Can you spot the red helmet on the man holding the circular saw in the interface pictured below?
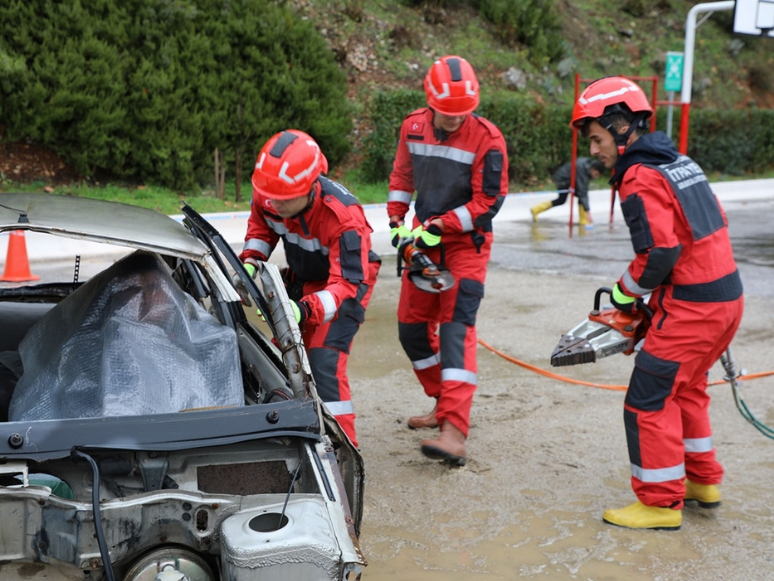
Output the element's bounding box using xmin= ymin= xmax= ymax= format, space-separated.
xmin=425 ymin=55 xmax=479 ymax=117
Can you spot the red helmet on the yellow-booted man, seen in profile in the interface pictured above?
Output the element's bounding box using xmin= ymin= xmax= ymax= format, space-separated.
xmin=570 ymin=77 xmax=653 ymax=129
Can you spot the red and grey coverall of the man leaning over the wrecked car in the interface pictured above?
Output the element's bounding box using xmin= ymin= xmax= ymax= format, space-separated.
xmin=239 ymin=177 xmax=381 ymax=446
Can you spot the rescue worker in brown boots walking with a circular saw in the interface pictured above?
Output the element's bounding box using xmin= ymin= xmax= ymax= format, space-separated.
xmin=387 ymin=56 xmax=508 ymax=466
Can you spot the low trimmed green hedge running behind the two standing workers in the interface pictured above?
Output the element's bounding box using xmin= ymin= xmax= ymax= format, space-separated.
xmin=361 ymin=90 xmax=774 ymax=184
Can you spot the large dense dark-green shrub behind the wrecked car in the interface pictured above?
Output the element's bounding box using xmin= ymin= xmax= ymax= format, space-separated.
xmin=0 ymin=0 xmax=352 ymax=189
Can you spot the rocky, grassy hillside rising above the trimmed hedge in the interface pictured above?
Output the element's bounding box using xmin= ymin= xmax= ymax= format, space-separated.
xmin=290 ymin=0 xmax=774 ymax=109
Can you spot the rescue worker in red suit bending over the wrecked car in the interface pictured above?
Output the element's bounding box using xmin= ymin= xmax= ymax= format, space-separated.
xmin=239 ymin=129 xmax=380 ymax=446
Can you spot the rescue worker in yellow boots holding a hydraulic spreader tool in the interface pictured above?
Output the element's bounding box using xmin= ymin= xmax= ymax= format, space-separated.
xmin=572 ymin=77 xmax=744 ymax=530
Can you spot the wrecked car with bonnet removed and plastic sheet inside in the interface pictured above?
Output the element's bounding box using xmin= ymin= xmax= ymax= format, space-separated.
xmin=0 ymin=194 xmax=365 ymax=581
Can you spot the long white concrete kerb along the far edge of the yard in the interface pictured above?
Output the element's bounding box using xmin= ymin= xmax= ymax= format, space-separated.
xmin=0 ymin=179 xmax=774 ymax=271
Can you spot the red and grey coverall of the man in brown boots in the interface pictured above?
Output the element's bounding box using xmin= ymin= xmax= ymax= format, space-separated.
xmin=387 ymin=108 xmax=508 ymax=436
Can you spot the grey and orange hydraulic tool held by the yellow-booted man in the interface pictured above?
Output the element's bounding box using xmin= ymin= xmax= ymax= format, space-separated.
xmin=551 ymin=287 xmax=653 ymax=367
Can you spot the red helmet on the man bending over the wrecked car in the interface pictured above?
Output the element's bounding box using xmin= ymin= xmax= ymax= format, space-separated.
xmin=253 ymin=129 xmax=328 ymax=200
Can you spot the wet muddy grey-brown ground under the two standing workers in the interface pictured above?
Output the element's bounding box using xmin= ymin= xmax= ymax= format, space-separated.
xmin=350 ymin=207 xmax=774 ymax=581
